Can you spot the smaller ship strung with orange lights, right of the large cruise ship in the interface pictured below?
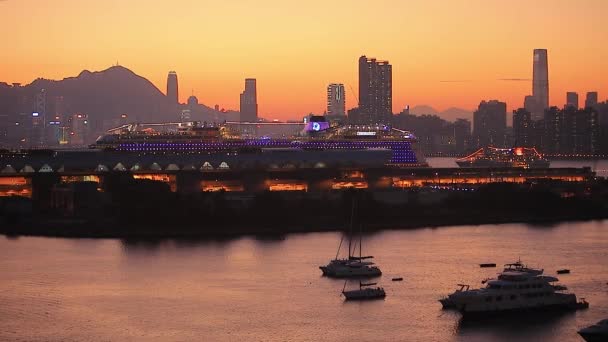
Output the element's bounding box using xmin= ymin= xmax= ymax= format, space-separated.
xmin=456 ymin=147 xmax=549 ymax=169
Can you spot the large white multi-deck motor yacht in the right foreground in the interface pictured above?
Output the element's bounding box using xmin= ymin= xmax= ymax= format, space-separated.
xmin=442 ymin=271 xmax=589 ymax=316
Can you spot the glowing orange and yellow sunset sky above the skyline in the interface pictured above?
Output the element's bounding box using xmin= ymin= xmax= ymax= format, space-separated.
xmin=0 ymin=0 xmax=608 ymax=119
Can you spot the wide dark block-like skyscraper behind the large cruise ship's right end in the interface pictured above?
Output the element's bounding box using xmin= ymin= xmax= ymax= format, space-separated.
xmin=359 ymin=56 xmax=393 ymax=124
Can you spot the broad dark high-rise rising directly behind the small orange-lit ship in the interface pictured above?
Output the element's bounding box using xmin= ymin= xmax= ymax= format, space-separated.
xmin=473 ymin=100 xmax=507 ymax=147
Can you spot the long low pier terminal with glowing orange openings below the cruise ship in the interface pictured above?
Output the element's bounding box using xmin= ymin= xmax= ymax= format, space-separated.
xmin=0 ymin=167 xmax=595 ymax=197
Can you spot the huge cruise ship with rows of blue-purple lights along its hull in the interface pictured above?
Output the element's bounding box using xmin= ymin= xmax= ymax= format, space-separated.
xmin=91 ymin=121 xmax=428 ymax=167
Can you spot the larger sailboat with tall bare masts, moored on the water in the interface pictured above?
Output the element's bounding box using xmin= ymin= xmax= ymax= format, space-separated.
xmin=319 ymin=199 xmax=382 ymax=278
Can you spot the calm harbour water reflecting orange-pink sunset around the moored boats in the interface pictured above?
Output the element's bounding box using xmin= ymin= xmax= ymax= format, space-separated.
xmin=0 ymin=221 xmax=608 ymax=341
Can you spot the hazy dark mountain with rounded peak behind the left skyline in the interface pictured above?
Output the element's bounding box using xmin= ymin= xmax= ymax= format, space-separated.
xmin=0 ymin=66 xmax=238 ymax=132
